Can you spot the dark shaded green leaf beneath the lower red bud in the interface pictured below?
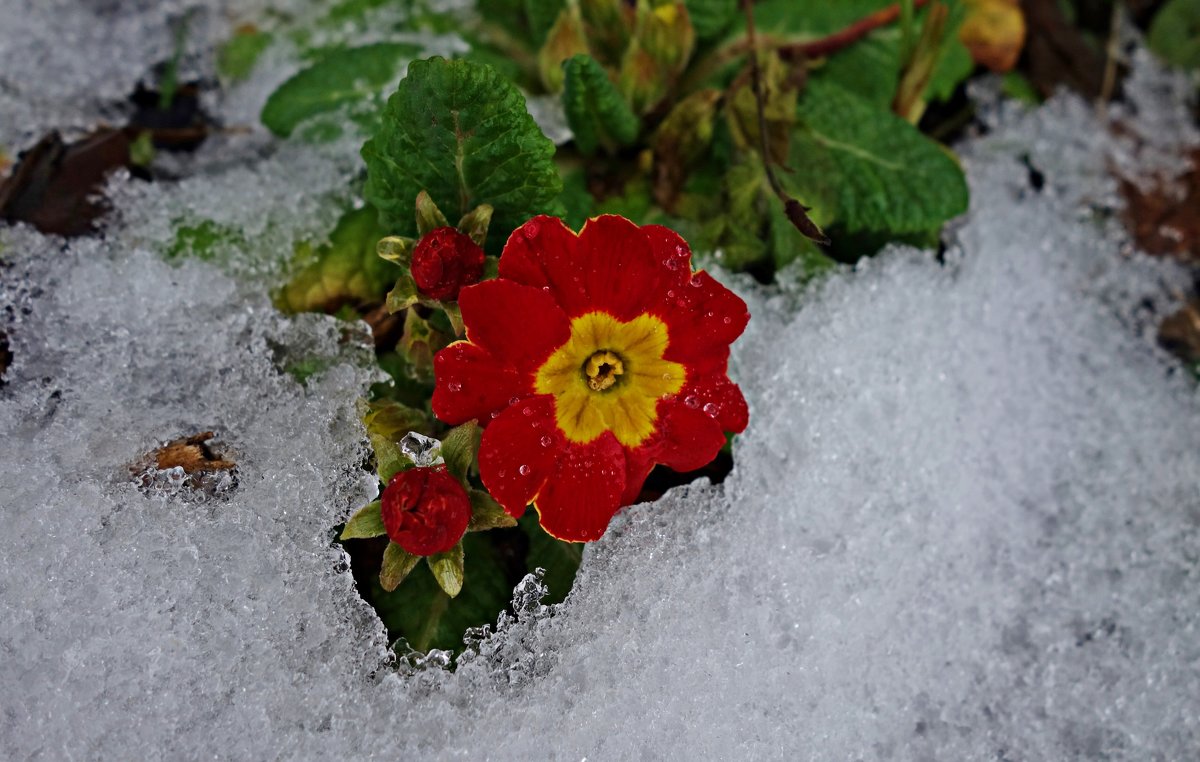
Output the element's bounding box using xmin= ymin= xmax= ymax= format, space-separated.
xmin=367 ymin=534 xmax=516 ymax=650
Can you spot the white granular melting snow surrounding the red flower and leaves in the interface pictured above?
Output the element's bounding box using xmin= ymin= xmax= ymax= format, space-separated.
xmin=0 ymin=4 xmax=1200 ymax=760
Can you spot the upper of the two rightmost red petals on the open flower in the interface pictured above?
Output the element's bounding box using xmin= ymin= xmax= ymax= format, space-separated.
xmin=653 ymin=271 xmax=750 ymax=371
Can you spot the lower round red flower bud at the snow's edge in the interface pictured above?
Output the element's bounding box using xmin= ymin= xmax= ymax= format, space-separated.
xmin=379 ymin=466 xmax=470 ymax=556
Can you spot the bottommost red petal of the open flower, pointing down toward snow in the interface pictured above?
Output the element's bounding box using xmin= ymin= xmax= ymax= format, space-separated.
xmin=535 ymin=432 xmax=625 ymax=542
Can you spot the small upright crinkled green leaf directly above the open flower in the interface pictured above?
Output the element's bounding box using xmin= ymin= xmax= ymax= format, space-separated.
xmin=563 ymin=54 xmax=641 ymax=156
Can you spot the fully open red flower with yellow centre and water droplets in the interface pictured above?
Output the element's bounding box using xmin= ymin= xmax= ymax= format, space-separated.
xmin=433 ymin=215 xmax=750 ymax=541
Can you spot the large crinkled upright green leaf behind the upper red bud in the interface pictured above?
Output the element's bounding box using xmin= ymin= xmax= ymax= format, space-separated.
xmin=362 ymin=58 xmax=562 ymax=248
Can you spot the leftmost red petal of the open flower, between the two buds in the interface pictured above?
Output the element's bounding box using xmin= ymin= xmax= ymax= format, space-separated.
xmin=433 ymin=341 xmax=530 ymax=425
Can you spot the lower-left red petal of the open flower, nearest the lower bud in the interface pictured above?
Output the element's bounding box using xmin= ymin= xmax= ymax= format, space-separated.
xmin=479 ymin=395 xmax=564 ymax=517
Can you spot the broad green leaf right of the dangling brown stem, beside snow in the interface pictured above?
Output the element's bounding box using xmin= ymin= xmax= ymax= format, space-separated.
xmin=785 ymin=82 xmax=967 ymax=233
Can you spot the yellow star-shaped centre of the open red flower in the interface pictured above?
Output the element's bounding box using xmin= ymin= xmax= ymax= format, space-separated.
xmin=534 ymin=312 xmax=686 ymax=448
